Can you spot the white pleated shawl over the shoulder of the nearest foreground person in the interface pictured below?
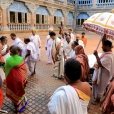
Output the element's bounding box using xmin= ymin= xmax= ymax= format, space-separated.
xmin=48 ymin=85 xmax=84 ymax=114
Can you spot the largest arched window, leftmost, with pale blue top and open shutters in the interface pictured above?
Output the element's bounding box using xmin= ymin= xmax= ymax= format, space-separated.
xmin=7 ymin=1 xmax=30 ymax=23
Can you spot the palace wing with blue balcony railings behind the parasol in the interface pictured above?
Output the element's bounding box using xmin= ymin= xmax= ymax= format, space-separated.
xmin=76 ymin=0 xmax=114 ymax=28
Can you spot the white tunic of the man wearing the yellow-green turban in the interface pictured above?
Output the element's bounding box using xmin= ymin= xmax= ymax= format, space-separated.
xmin=30 ymin=35 xmax=41 ymax=55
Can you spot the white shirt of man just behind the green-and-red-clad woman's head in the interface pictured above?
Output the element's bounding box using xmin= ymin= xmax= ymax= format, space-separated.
xmin=13 ymin=37 xmax=25 ymax=57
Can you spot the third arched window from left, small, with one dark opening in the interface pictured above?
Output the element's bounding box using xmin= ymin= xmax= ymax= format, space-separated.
xmin=54 ymin=9 xmax=64 ymax=24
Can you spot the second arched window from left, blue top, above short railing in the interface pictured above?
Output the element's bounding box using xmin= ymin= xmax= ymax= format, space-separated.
xmin=35 ymin=6 xmax=49 ymax=24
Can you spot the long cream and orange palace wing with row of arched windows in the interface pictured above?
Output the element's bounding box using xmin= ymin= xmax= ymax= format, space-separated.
xmin=0 ymin=0 xmax=75 ymax=33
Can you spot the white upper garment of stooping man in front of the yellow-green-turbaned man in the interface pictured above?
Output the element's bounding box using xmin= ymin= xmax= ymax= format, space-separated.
xmin=26 ymin=42 xmax=38 ymax=61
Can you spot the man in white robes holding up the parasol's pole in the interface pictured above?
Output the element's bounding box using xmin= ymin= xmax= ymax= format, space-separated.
xmin=92 ymin=40 xmax=114 ymax=104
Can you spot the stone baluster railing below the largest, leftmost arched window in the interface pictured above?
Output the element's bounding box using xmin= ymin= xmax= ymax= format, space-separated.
xmin=8 ymin=23 xmax=30 ymax=31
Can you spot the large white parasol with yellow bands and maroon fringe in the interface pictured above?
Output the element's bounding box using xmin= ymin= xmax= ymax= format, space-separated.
xmin=83 ymin=10 xmax=114 ymax=50
